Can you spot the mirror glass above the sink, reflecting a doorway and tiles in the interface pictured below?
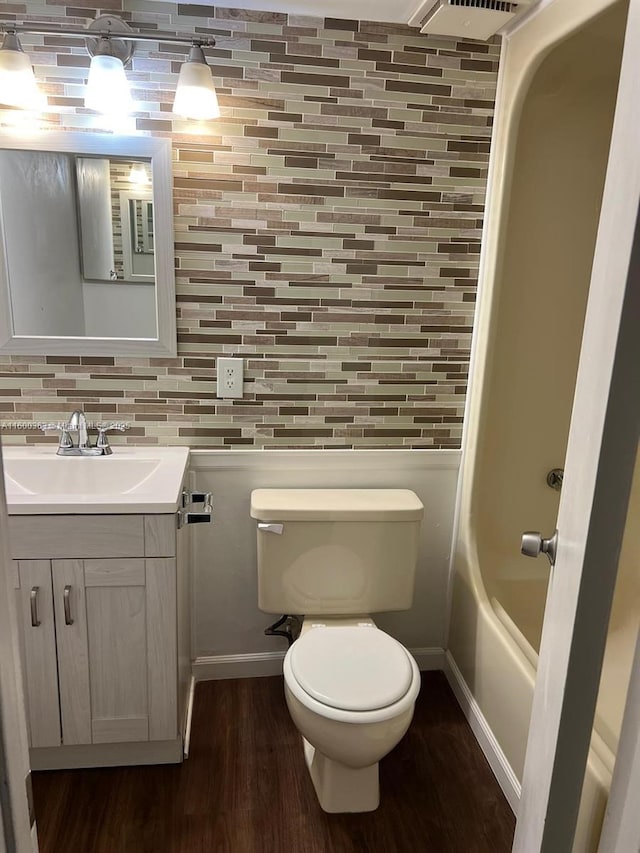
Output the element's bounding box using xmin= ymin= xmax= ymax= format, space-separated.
xmin=0 ymin=149 xmax=158 ymax=339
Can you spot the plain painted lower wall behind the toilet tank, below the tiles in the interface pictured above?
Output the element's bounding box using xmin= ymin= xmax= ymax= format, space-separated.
xmin=186 ymin=450 xmax=460 ymax=675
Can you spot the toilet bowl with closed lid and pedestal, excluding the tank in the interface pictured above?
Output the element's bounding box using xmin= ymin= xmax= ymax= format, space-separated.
xmin=284 ymin=617 xmax=420 ymax=812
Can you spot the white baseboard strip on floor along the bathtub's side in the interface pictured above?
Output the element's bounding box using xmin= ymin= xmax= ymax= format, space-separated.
xmin=444 ymin=652 xmax=521 ymax=816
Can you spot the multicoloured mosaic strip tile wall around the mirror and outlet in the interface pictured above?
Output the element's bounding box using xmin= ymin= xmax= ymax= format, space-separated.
xmin=0 ymin=0 xmax=499 ymax=448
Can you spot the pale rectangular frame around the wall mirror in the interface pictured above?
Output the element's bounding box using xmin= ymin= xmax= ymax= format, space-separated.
xmin=0 ymin=131 xmax=177 ymax=357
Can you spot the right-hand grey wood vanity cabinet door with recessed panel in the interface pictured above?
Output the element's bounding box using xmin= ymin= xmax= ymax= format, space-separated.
xmin=45 ymin=558 xmax=178 ymax=746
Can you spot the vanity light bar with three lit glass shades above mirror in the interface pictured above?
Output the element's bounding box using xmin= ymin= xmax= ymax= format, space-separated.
xmin=0 ymin=15 xmax=220 ymax=119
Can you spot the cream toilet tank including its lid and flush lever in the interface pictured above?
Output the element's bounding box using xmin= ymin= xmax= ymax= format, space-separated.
xmin=251 ymin=489 xmax=424 ymax=616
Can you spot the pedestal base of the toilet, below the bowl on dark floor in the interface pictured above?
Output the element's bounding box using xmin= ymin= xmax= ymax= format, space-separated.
xmin=302 ymin=738 xmax=380 ymax=814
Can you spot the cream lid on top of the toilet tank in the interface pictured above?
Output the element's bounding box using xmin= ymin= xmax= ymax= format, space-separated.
xmin=251 ymin=489 xmax=424 ymax=521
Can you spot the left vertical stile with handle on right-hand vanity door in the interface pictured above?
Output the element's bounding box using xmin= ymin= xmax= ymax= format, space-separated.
xmin=52 ymin=560 xmax=91 ymax=745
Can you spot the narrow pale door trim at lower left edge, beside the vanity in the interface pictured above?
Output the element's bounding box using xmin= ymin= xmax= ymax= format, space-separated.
xmin=0 ymin=446 xmax=38 ymax=853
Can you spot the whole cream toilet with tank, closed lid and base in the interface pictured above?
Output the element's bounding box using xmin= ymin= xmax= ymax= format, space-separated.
xmin=251 ymin=489 xmax=424 ymax=812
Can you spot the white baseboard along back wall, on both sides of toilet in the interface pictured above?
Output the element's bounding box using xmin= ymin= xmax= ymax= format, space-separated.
xmin=191 ymin=648 xmax=445 ymax=681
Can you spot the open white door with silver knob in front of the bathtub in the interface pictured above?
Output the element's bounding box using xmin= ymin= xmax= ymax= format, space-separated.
xmin=513 ymin=0 xmax=640 ymax=853
